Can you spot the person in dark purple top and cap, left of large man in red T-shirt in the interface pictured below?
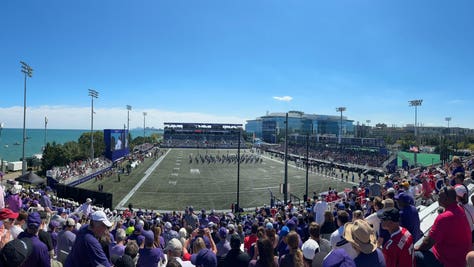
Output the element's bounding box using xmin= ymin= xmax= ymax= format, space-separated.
xmin=395 ymin=192 xmax=423 ymax=243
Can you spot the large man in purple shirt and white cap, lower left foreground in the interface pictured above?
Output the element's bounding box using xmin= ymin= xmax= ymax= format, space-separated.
xmin=64 ymin=211 xmax=112 ymax=267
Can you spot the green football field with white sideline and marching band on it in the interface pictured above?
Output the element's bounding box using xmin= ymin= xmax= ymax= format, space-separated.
xmin=79 ymin=149 xmax=352 ymax=211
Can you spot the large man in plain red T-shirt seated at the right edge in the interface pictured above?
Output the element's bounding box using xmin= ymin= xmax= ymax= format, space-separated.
xmin=415 ymin=186 xmax=471 ymax=267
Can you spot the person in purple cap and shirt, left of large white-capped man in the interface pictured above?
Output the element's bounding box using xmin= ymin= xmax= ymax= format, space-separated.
xmin=18 ymin=212 xmax=51 ymax=267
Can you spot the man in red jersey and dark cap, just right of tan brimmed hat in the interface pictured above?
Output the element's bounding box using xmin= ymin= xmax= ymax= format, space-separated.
xmin=380 ymin=208 xmax=415 ymax=267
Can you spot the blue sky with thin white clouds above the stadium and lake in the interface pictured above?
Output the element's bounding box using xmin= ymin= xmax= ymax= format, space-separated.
xmin=0 ymin=0 xmax=474 ymax=129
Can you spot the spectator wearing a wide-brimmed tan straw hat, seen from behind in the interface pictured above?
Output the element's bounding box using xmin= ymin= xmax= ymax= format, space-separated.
xmin=344 ymin=220 xmax=385 ymax=267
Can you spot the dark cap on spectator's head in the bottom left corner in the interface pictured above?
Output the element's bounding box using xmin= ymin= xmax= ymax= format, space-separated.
xmin=0 ymin=238 xmax=33 ymax=267
